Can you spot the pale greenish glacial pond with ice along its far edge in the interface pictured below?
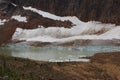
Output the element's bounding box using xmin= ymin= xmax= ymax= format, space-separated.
xmin=0 ymin=44 xmax=120 ymax=62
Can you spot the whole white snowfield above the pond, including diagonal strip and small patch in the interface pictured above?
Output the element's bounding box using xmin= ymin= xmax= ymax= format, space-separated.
xmin=12 ymin=7 xmax=120 ymax=42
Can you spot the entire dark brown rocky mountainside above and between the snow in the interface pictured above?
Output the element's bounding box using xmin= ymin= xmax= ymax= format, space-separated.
xmin=0 ymin=0 xmax=120 ymax=43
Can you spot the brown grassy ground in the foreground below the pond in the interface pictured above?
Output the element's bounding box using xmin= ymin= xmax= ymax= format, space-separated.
xmin=0 ymin=52 xmax=120 ymax=80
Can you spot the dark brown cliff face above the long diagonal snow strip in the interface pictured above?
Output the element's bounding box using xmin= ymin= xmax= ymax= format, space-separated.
xmin=6 ymin=0 xmax=120 ymax=24
